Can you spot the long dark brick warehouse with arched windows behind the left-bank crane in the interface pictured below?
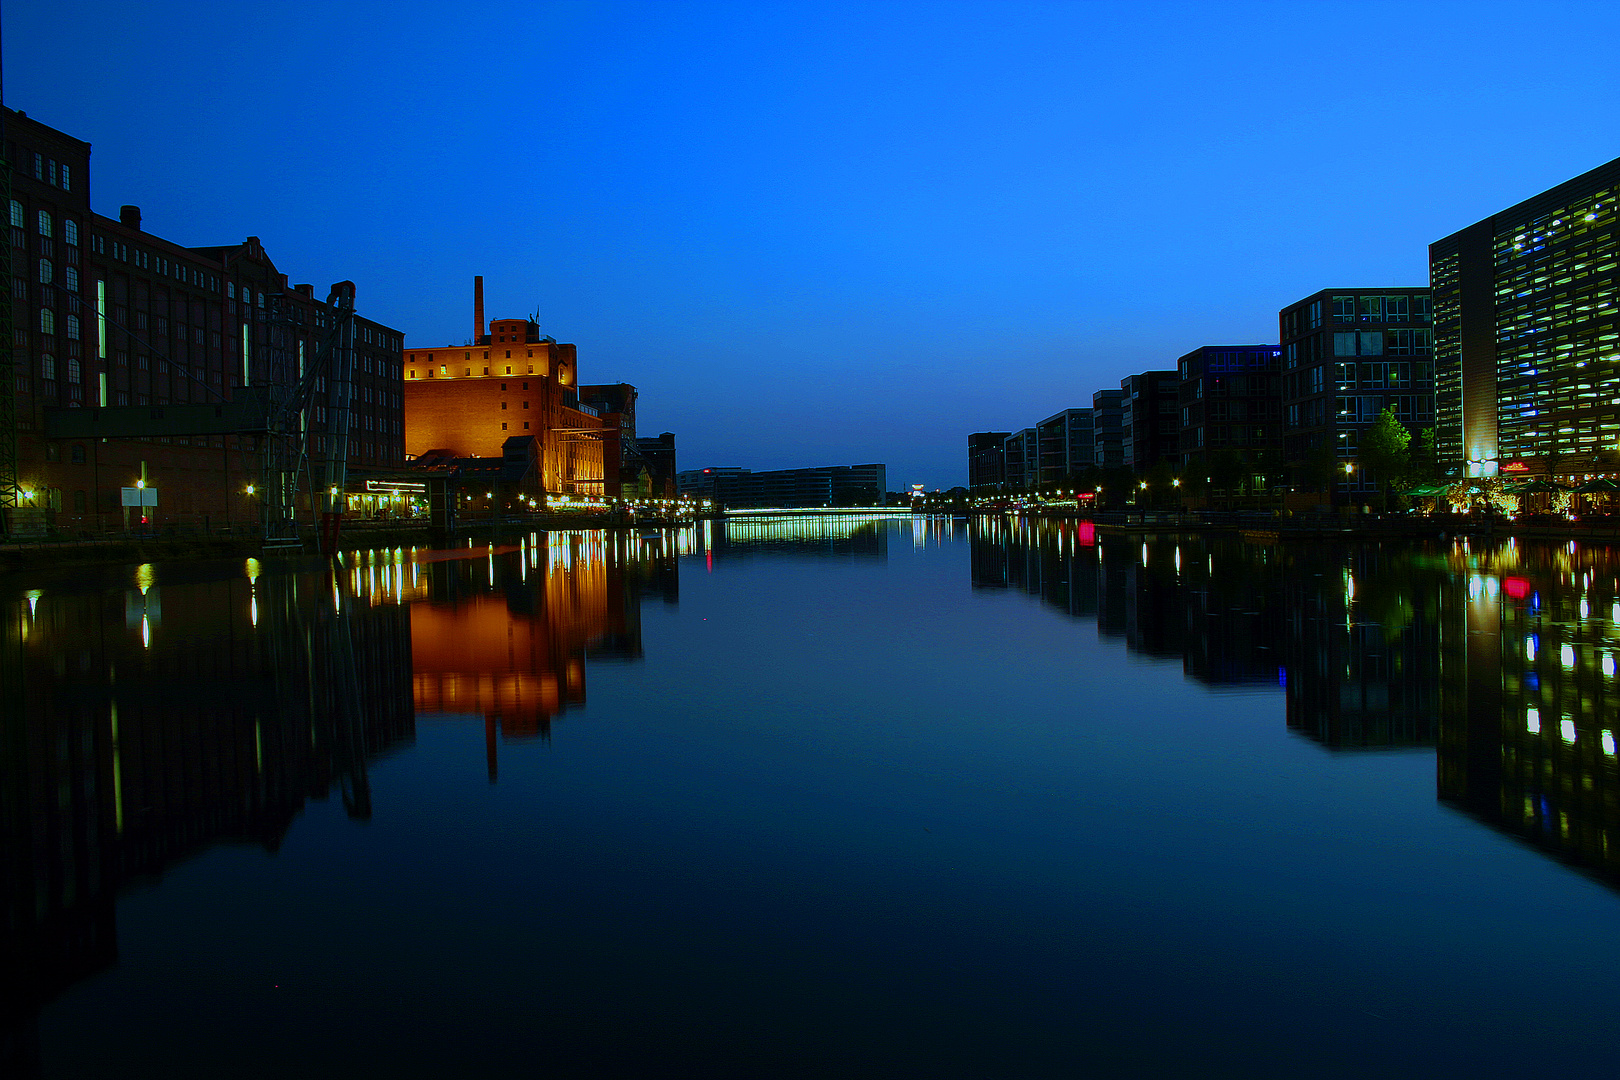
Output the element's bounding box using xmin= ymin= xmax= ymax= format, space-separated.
xmin=0 ymin=110 xmax=403 ymax=531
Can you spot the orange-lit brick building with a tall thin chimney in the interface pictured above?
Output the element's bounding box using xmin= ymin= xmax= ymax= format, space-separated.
xmin=405 ymin=277 xmax=617 ymax=495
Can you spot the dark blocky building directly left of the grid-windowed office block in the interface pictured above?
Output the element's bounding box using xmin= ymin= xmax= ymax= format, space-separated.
xmin=1176 ymin=345 xmax=1283 ymax=466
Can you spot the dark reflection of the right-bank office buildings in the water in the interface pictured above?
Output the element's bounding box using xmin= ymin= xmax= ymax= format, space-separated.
xmin=972 ymin=520 xmax=1620 ymax=887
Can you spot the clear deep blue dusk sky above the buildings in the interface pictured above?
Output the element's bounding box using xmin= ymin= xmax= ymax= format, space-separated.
xmin=3 ymin=0 xmax=1620 ymax=489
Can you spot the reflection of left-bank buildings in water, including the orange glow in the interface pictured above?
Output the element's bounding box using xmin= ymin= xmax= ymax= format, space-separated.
xmin=0 ymin=529 xmax=677 ymax=1075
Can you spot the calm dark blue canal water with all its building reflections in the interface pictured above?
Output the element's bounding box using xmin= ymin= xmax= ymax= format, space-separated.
xmin=0 ymin=520 xmax=1620 ymax=1078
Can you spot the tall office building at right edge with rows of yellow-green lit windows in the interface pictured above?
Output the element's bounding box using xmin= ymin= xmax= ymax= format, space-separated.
xmin=1429 ymin=159 xmax=1620 ymax=476
